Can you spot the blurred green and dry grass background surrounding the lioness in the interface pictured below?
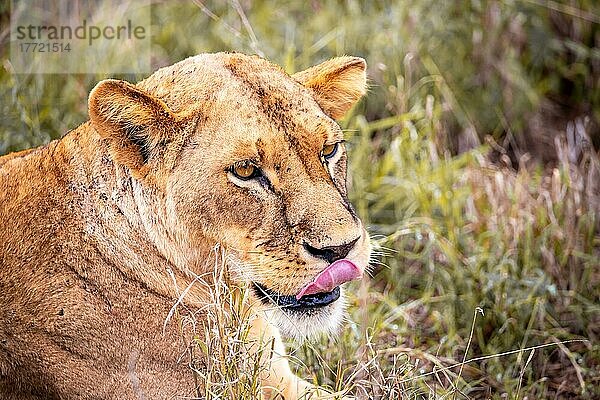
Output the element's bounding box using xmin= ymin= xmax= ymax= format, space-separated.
xmin=0 ymin=0 xmax=600 ymax=399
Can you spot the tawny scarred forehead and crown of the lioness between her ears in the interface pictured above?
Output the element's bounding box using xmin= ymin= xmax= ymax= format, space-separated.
xmin=139 ymin=53 xmax=343 ymax=170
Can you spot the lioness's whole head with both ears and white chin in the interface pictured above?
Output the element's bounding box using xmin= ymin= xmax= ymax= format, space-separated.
xmin=89 ymin=53 xmax=370 ymax=337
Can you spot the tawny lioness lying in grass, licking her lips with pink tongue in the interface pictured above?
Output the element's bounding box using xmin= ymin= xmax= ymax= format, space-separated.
xmin=0 ymin=53 xmax=370 ymax=400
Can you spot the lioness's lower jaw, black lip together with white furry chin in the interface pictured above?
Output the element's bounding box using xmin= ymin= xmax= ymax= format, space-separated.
xmin=252 ymin=283 xmax=346 ymax=341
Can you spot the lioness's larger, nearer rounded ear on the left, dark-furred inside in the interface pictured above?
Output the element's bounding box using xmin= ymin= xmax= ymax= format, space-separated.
xmin=88 ymin=79 xmax=176 ymax=172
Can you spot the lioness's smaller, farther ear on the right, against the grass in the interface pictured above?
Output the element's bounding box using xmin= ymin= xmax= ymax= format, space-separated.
xmin=292 ymin=56 xmax=367 ymax=119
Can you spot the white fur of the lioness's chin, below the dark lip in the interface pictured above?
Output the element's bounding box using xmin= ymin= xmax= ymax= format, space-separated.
xmin=264 ymin=288 xmax=346 ymax=342
